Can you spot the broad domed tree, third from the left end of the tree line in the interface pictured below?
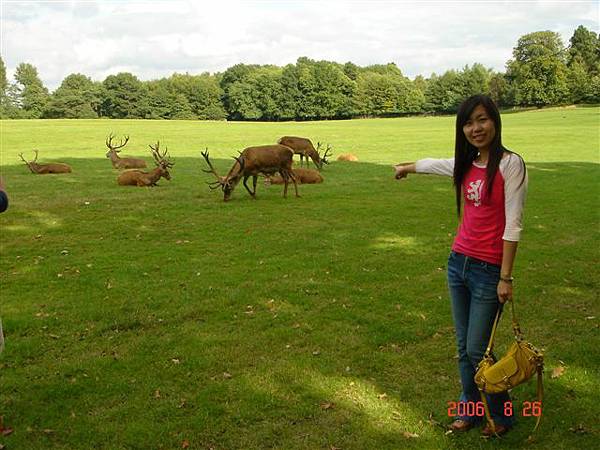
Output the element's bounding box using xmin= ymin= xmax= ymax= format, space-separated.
xmin=46 ymin=73 xmax=101 ymax=119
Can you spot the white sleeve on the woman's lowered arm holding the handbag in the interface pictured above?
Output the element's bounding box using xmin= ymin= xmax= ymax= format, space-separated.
xmin=500 ymin=153 xmax=528 ymax=242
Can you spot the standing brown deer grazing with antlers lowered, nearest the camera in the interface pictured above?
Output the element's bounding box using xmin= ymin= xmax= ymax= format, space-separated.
xmin=202 ymin=144 xmax=300 ymax=201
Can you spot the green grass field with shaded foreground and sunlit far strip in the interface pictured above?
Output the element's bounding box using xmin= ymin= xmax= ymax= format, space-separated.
xmin=0 ymin=108 xmax=600 ymax=450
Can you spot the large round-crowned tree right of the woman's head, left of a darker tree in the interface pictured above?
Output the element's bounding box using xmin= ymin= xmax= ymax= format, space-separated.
xmin=507 ymin=31 xmax=569 ymax=106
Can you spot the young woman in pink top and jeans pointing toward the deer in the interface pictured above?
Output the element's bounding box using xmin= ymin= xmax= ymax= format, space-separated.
xmin=394 ymin=95 xmax=527 ymax=436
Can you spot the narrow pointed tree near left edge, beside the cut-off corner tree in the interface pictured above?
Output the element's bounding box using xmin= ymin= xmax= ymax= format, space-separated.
xmin=14 ymin=63 xmax=49 ymax=119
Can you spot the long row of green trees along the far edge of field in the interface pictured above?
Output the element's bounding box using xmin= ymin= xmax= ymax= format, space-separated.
xmin=0 ymin=26 xmax=600 ymax=121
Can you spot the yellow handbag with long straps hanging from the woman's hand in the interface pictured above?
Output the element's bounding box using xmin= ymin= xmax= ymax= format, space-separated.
xmin=475 ymin=301 xmax=544 ymax=432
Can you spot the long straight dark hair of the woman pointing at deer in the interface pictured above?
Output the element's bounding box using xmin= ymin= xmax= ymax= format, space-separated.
xmin=454 ymin=94 xmax=525 ymax=216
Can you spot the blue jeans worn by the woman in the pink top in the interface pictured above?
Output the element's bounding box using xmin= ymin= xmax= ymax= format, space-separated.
xmin=448 ymin=252 xmax=514 ymax=427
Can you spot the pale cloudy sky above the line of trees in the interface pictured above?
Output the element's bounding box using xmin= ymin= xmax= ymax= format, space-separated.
xmin=0 ymin=0 xmax=600 ymax=90
